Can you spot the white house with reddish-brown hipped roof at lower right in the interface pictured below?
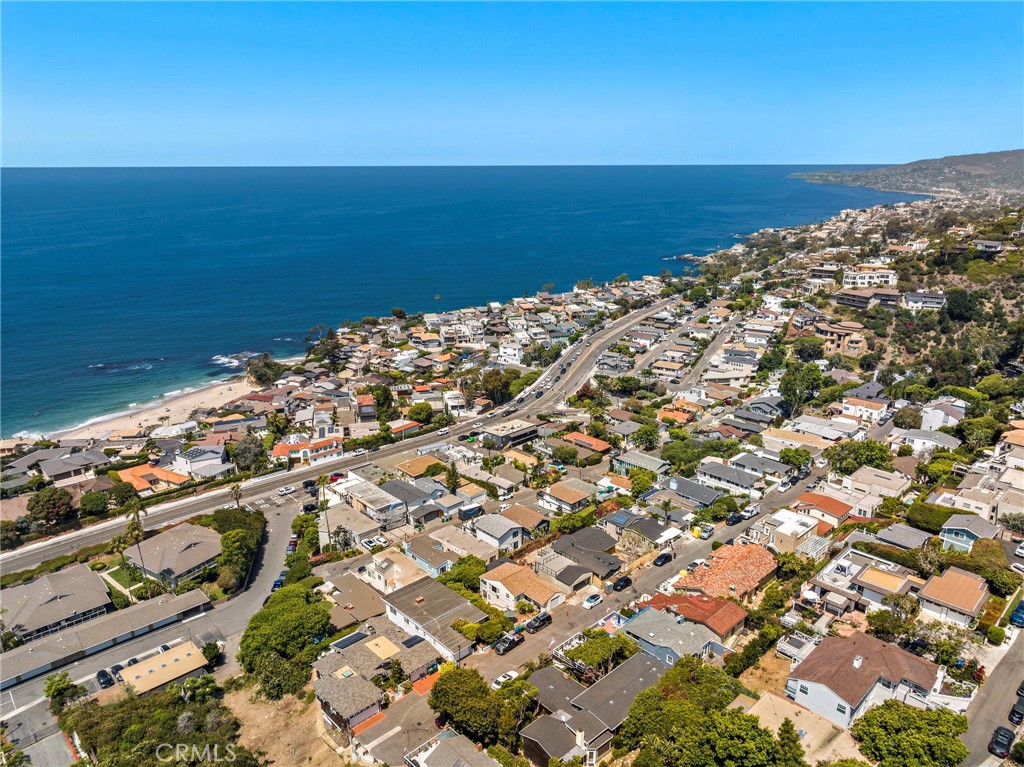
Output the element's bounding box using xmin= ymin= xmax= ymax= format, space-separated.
xmin=785 ymin=632 xmax=943 ymax=727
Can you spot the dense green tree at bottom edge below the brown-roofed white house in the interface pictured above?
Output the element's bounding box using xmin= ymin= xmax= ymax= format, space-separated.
xmin=851 ymin=700 xmax=969 ymax=767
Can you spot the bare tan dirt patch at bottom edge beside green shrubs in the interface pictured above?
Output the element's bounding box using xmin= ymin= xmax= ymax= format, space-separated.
xmin=224 ymin=689 xmax=346 ymax=767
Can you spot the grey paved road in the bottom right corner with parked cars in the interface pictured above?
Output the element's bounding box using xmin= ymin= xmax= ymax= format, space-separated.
xmin=961 ymin=629 xmax=1024 ymax=767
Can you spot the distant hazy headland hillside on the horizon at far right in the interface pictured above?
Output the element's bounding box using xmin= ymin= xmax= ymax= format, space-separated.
xmin=795 ymin=150 xmax=1024 ymax=195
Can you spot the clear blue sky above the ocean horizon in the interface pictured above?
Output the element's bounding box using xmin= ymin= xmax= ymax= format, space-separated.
xmin=0 ymin=2 xmax=1024 ymax=167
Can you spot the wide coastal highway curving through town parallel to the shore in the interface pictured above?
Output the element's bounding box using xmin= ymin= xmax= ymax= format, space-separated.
xmin=0 ymin=299 xmax=675 ymax=572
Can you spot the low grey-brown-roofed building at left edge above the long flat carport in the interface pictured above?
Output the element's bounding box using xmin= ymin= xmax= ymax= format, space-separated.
xmin=3 ymin=564 xmax=113 ymax=643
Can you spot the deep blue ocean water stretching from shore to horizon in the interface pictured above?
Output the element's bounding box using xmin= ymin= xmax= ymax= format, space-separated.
xmin=0 ymin=166 xmax=914 ymax=436
